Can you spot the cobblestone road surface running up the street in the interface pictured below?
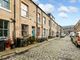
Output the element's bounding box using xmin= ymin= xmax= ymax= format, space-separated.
xmin=6 ymin=37 xmax=80 ymax=60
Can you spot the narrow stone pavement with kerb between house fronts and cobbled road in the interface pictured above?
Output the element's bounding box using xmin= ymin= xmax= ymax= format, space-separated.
xmin=0 ymin=38 xmax=56 ymax=60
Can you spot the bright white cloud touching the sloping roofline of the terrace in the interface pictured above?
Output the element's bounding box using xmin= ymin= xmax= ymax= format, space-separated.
xmin=39 ymin=4 xmax=54 ymax=13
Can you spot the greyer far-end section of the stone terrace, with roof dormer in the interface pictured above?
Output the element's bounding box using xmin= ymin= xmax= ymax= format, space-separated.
xmin=48 ymin=14 xmax=62 ymax=37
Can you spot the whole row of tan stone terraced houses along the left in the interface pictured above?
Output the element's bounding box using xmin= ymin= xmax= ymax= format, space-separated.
xmin=0 ymin=0 xmax=62 ymax=50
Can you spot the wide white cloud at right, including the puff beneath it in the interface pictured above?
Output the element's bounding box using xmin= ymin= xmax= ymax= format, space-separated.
xmin=58 ymin=5 xmax=79 ymax=18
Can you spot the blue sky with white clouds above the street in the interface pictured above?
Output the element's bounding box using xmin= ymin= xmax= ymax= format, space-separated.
xmin=33 ymin=0 xmax=80 ymax=26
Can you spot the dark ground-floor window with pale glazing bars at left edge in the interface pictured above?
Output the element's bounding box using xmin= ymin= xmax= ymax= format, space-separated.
xmin=0 ymin=20 xmax=9 ymax=37
